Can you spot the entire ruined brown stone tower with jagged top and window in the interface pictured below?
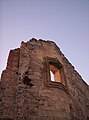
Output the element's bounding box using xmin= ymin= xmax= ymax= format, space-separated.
xmin=0 ymin=38 xmax=89 ymax=120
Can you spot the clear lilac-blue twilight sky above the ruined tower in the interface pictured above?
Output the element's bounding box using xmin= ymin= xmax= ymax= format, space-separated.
xmin=0 ymin=0 xmax=89 ymax=84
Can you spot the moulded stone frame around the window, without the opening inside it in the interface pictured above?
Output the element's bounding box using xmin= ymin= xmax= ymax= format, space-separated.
xmin=44 ymin=57 xmax=68 ymax=93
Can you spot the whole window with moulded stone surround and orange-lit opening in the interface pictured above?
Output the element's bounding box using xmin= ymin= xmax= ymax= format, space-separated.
xmin=45 ymin=57 xmax=67 ymax=91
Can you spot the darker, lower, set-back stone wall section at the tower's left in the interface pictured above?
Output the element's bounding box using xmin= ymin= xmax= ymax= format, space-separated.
xmin=0 ymin=49 xmax=19 ymax=119
